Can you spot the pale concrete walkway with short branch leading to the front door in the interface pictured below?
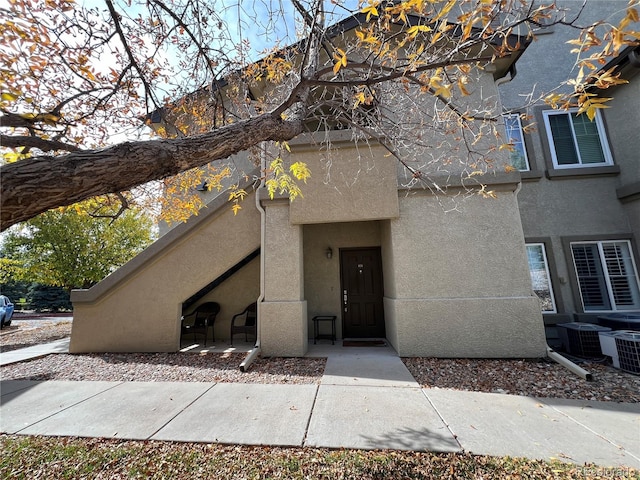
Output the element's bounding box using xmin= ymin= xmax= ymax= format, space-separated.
xmin=0 ymin=346 xmax=640 ymax=468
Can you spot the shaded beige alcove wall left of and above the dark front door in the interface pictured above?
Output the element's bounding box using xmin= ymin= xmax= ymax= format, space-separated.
xmin=303 ymin=222 xmax=381 ymax=338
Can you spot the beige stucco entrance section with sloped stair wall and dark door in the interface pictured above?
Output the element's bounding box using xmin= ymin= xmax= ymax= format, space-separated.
xmin=71 ymin=126 xmax=545 ymax=357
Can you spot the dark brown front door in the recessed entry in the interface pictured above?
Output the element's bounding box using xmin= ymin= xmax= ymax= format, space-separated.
xmin=340 ymin=247 xmax=385 ymax=338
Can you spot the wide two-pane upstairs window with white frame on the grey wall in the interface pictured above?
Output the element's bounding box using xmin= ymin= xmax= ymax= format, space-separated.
xmin=543 ymin=110 xmax=613 ymax=169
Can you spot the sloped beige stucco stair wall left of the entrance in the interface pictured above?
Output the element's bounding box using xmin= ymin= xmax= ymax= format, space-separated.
xmin=69 ymin=191 xmax=260 ymax=353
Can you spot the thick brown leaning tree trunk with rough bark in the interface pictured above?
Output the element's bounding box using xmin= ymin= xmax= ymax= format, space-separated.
xmin=0 ymin=114 xmax=303 ymax=230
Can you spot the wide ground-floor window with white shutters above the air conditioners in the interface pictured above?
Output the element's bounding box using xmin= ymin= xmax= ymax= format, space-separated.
xmin=571 ymin=240 xmax=640 ymax=312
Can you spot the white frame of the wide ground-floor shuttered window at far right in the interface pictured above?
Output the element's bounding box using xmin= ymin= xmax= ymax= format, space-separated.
xmin=563 ymin=235 xmax=640 ymax=314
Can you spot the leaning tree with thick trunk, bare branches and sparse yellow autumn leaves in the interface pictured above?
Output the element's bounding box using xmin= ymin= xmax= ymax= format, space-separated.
xmin=0 ymin=0 xmax=640 ymax=228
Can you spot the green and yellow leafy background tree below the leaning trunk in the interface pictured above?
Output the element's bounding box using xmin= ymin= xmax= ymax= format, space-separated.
xmin=0 ymin=201 xmax=153 ymax=290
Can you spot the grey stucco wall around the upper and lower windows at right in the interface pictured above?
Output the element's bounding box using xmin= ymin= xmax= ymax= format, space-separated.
xmin=508 ymin=79 xmax=640 ymax=314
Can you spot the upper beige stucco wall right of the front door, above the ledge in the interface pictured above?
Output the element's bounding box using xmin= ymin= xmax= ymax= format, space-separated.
xmin=390 ymin=192 xmax=531 ymax=298
